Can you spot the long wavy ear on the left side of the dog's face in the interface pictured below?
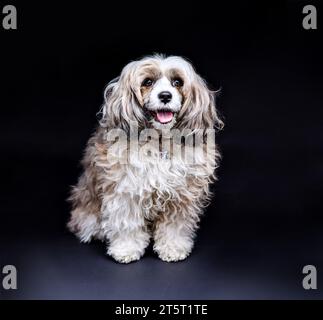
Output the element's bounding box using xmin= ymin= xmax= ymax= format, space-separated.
xmin=98 ymin=62 xmax=144 ymax=132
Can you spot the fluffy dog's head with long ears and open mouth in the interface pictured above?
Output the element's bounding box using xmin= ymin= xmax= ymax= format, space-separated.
xmin=100 ymin=55 xmax=223 ymax=130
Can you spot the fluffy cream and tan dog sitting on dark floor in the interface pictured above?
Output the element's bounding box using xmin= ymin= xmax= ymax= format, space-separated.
xmin=68 ymin=54 xmax=223 ymax=263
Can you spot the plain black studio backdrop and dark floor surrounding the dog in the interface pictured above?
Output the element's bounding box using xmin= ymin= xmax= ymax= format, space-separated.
xmin=0 ymin=1 xmax=323 ymax=299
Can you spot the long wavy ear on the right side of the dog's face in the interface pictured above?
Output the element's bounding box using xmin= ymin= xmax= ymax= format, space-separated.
xmin=179 ymin=74 xmax=224 ymax=130
